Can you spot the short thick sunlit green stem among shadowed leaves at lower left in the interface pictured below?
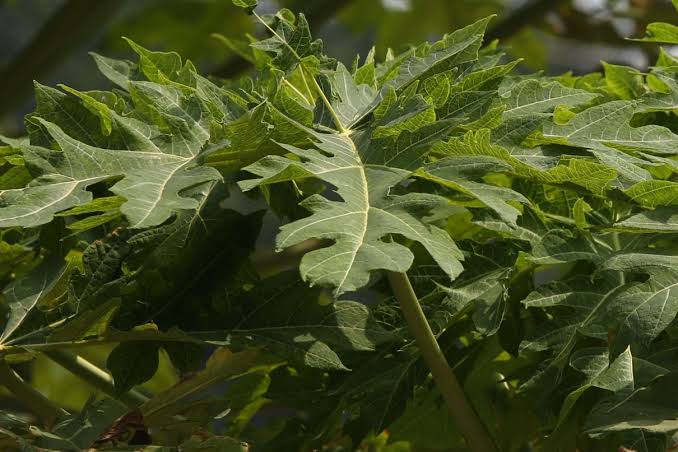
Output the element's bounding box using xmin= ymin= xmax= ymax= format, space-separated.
xmin=43 ymin=350 xmax=148 ymax=408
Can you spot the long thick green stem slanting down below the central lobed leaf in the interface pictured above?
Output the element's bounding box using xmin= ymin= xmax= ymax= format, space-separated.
xmin=388 ymin=272 xmax=497 ymax=452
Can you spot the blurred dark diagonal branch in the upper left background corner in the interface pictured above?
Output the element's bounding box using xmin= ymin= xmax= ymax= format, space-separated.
xmin=0 ymin=0 xmax=125 ymax=120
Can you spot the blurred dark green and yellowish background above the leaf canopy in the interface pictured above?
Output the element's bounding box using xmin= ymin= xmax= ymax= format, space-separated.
xmin=0 ymin=0 xmax=676 ymax=136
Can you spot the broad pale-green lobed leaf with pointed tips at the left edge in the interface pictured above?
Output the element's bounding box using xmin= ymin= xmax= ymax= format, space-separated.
xmin=0 ymin=108 xmax=220 ymax=228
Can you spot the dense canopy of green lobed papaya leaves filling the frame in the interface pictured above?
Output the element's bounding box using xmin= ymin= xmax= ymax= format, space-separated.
xmin=0 ymin=0 xmax=678 ymax=451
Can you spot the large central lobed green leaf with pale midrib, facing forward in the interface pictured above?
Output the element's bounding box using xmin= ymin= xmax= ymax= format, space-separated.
xmin=240 ymin=109 xmax=461 ymax=296
